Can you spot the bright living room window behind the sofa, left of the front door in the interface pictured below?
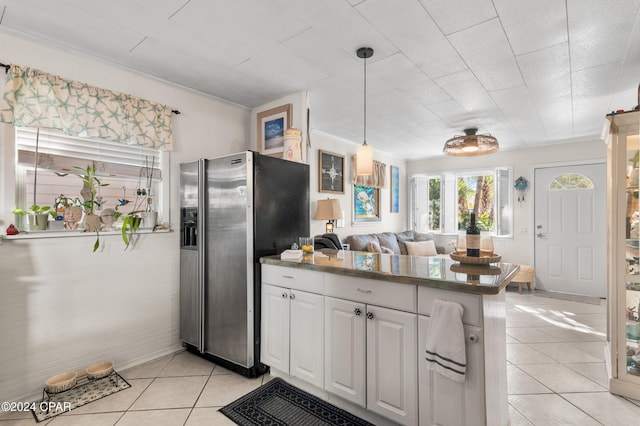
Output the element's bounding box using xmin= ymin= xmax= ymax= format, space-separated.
xmin=410 ymin=168 xmax=512 ymax=237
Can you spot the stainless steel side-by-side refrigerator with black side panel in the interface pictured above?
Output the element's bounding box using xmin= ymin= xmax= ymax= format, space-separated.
xmin=180 ymin=151 xmax=309 ymax=377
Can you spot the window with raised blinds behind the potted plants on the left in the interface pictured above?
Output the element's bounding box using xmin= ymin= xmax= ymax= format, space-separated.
xmin=16 ymin=128 xmax=162 ymax=220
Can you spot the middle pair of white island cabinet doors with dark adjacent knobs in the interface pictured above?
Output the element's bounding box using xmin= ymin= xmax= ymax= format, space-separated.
xmin=325 ymin=297 xmax=418 ymax=425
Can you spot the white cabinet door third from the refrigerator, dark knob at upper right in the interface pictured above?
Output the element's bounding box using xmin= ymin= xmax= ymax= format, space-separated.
xmin=324 ymin=297 xmax=366 ymax=407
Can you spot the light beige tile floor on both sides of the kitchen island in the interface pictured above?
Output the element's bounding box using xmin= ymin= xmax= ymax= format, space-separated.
xmin=0 ymin=291 xmax=640 ymax=426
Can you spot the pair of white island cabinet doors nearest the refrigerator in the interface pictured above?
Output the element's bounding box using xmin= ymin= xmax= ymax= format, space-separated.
xmin=260 ymin=284 xmax=324 ymax=388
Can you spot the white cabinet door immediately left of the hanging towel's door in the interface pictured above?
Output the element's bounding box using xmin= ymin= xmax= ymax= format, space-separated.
xmin=367 ymin=305 xmax=418 ymax=425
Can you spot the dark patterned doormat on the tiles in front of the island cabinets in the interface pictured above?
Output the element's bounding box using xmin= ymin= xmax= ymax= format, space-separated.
xmin=220 ymin=378 xmax=373 ymax=426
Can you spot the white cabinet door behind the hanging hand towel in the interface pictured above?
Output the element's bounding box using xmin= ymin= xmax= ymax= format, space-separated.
xmin=418 ymin=315 xmax=486 ymax=426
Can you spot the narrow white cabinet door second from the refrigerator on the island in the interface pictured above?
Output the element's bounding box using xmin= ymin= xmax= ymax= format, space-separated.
xmin=289 ymin=290 xmax=324 ymax=389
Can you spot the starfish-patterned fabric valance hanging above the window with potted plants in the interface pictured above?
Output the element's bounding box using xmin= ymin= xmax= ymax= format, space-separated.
xmin=0 ymin=65 xmax=173 ymax=151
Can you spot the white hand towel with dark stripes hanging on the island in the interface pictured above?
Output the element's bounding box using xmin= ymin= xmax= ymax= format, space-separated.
xmin=426 ymin=300 xmax=467 ymax=382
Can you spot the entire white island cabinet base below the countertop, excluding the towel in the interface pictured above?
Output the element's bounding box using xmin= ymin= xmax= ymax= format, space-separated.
xmin=260 ymin=265 xmax=509 ymax=426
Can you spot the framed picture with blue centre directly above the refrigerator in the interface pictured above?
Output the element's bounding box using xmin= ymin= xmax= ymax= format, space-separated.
xmin=256 ymin=104 xmax=293 ymax=157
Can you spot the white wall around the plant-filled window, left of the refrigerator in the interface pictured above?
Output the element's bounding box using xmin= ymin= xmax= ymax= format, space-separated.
xmin=0 ymin=33 xmax=253 ymax=401
